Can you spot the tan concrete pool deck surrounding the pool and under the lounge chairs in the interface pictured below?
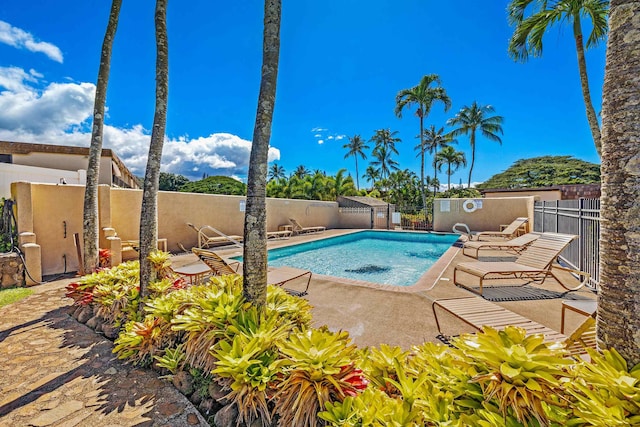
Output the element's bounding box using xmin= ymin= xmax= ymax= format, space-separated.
xmin=181 ymin=230 xmax=595 ymax=349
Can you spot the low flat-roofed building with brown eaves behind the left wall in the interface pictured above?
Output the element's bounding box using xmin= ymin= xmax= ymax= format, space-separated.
xmin=0 ymin=141 xmax=140 ymax=197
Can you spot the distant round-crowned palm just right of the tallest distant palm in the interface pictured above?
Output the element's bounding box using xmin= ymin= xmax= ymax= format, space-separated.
xmin=447 ymin=101 xmax=504 ymax=188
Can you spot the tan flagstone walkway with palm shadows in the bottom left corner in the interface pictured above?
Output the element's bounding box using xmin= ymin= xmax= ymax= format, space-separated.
xmin=0 ymin=279 xmax=208 ymax=427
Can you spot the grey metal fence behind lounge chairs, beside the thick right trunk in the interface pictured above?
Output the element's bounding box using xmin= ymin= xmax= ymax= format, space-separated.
xmin=533 ymin=199 xmax=600 ymax=290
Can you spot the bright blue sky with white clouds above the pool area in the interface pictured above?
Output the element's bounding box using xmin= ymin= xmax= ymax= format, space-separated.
xmin=0 ymin=0 xmax=605 ymax=183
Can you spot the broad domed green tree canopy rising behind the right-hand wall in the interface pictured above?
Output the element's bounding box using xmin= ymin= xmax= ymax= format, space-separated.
xmin=478 ymin=156 xmax=600 ymax=189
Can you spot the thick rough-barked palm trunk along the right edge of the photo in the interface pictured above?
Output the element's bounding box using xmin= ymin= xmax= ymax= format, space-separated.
xmin=598 ymin=0 xmax=640 ymax=367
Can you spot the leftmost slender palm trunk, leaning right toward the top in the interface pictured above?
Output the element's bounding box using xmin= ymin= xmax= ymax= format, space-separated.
xmin=82 ymin=0 xmax=122 ymax=274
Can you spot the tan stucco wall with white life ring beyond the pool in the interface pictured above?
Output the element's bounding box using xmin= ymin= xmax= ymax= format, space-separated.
xmin=433 ymin=197 xmax=534 ymax=232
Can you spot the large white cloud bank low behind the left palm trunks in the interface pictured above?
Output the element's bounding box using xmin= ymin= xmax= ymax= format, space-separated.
xmin=0 ymin=67 xmax=280 ymax=179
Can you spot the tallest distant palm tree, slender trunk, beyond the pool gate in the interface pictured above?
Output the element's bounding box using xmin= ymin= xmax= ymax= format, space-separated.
xmin=395 ymin=74 xmax=451 ymax=213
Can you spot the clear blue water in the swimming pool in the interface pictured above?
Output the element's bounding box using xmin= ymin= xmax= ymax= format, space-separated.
xmin=262 ymin=231 xmax=459 ymax=286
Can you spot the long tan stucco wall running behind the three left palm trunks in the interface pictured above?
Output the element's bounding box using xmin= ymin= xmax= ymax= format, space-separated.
xmin=11 ymin=182 xmax=343 ymax=280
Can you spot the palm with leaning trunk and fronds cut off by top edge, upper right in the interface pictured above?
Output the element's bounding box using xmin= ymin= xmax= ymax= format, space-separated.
xmin=507 ymin=0 xmax=609 ymax=155
